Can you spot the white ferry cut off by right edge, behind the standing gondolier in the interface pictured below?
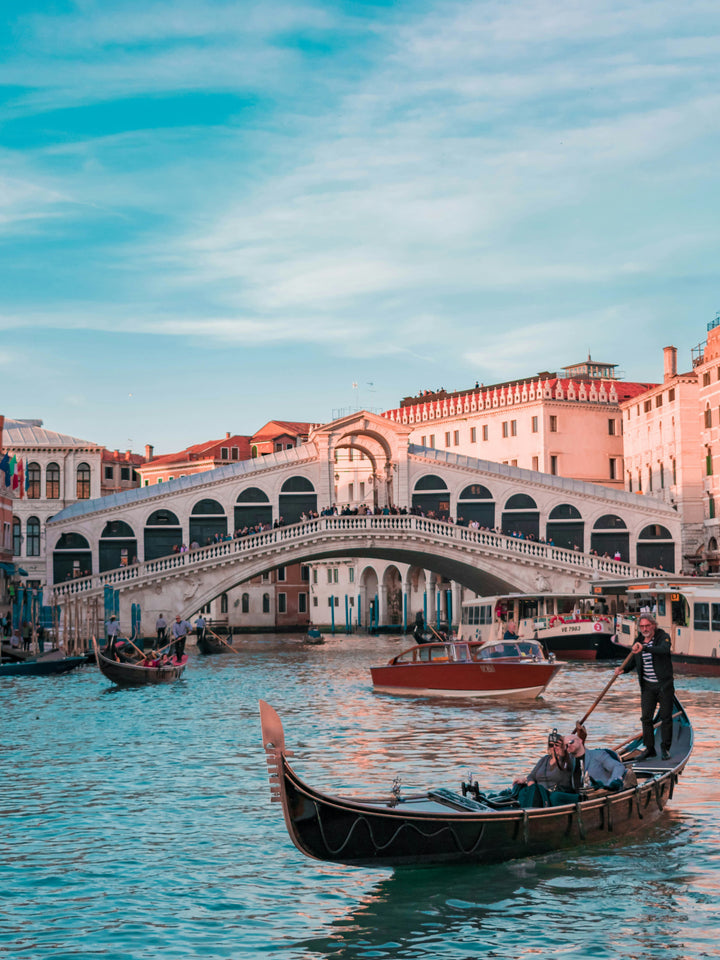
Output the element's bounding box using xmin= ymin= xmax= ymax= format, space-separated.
xmin=593 ymin=577 xmax=720 ymax=676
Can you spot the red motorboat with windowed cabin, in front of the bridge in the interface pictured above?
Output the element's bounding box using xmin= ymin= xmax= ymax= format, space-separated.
xmin=370 ymin=640 xmax=563 ymax=697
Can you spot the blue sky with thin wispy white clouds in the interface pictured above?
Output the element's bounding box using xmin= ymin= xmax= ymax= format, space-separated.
xmin=0 ymin=0 xmax=720 ymax=454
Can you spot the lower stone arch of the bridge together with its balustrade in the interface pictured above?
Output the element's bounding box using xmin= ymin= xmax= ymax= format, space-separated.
xmin=54 ymin=516 xmax=654 ymax=623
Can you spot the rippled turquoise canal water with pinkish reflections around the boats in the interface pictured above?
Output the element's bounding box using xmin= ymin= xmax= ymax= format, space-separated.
xmin=0 ymin=636 xmax=720 ymax=960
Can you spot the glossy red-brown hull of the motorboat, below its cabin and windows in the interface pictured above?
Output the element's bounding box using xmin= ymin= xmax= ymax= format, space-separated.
xmin=370 ymin=661 xmax=561 ymax=697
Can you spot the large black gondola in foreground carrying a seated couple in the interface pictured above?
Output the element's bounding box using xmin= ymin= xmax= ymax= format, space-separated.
xmin=260 ymin=700 xmax=693 ymax=867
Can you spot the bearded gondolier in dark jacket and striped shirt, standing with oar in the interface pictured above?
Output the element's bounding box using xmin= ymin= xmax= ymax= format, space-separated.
xmin=615 ymin=613 xmax=675 ymax=760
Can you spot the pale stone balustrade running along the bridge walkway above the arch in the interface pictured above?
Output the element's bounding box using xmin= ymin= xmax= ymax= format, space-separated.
xmin=52 ymin=515 xmax=658 ymax=602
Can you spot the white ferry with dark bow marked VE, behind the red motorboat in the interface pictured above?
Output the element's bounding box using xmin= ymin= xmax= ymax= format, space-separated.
xmin=459 ymin=593 xmax=622 ymax=660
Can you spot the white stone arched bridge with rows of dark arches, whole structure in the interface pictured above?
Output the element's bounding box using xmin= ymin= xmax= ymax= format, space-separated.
xmin=47 ymin=412 xmax=681 ymax=623
